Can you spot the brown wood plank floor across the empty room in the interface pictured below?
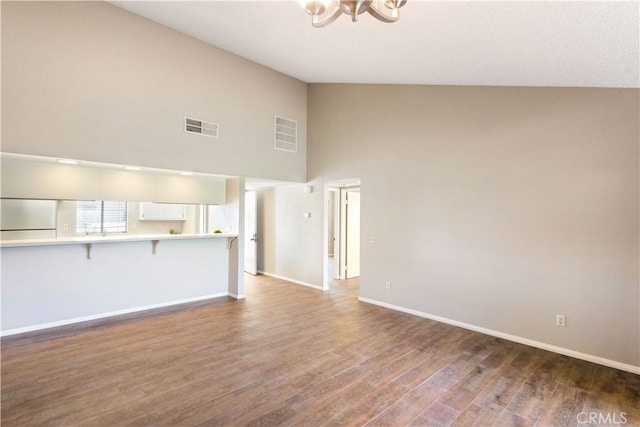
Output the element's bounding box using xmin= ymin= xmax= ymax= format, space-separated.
xmin=1 ymin=276 xmax=640 ymax=426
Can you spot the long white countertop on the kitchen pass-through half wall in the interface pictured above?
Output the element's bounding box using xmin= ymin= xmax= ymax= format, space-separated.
xmin=0 ymin=233 xmax=238 ymax=248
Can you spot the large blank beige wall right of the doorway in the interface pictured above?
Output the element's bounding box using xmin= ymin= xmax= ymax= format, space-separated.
xmin=308 ymin=84 xmax=640 ymax=366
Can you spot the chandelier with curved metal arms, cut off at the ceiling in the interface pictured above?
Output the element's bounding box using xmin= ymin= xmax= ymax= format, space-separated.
xmin=300 ymin=0 xmax=407 ymax=27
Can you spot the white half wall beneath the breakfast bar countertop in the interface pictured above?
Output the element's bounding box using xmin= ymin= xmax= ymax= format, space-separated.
xmin=0 ymin=234 xmax=238 ymax=336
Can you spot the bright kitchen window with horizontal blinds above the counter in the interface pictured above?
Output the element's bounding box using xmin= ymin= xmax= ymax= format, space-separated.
xmin=76 ymin=200 xmax=127 ymax=233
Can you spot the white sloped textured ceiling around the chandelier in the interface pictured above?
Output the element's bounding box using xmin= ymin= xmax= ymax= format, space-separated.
xmin=113 ymin=0 xmax=640 ymax=88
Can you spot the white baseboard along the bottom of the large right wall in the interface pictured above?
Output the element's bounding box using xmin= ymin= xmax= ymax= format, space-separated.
xmin=358 ymin=297 xmax=640 ymax=375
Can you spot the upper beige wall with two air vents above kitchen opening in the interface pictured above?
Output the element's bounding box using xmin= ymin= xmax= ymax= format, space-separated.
xmin=1 ymin=2 xmax=306 ymax=182
